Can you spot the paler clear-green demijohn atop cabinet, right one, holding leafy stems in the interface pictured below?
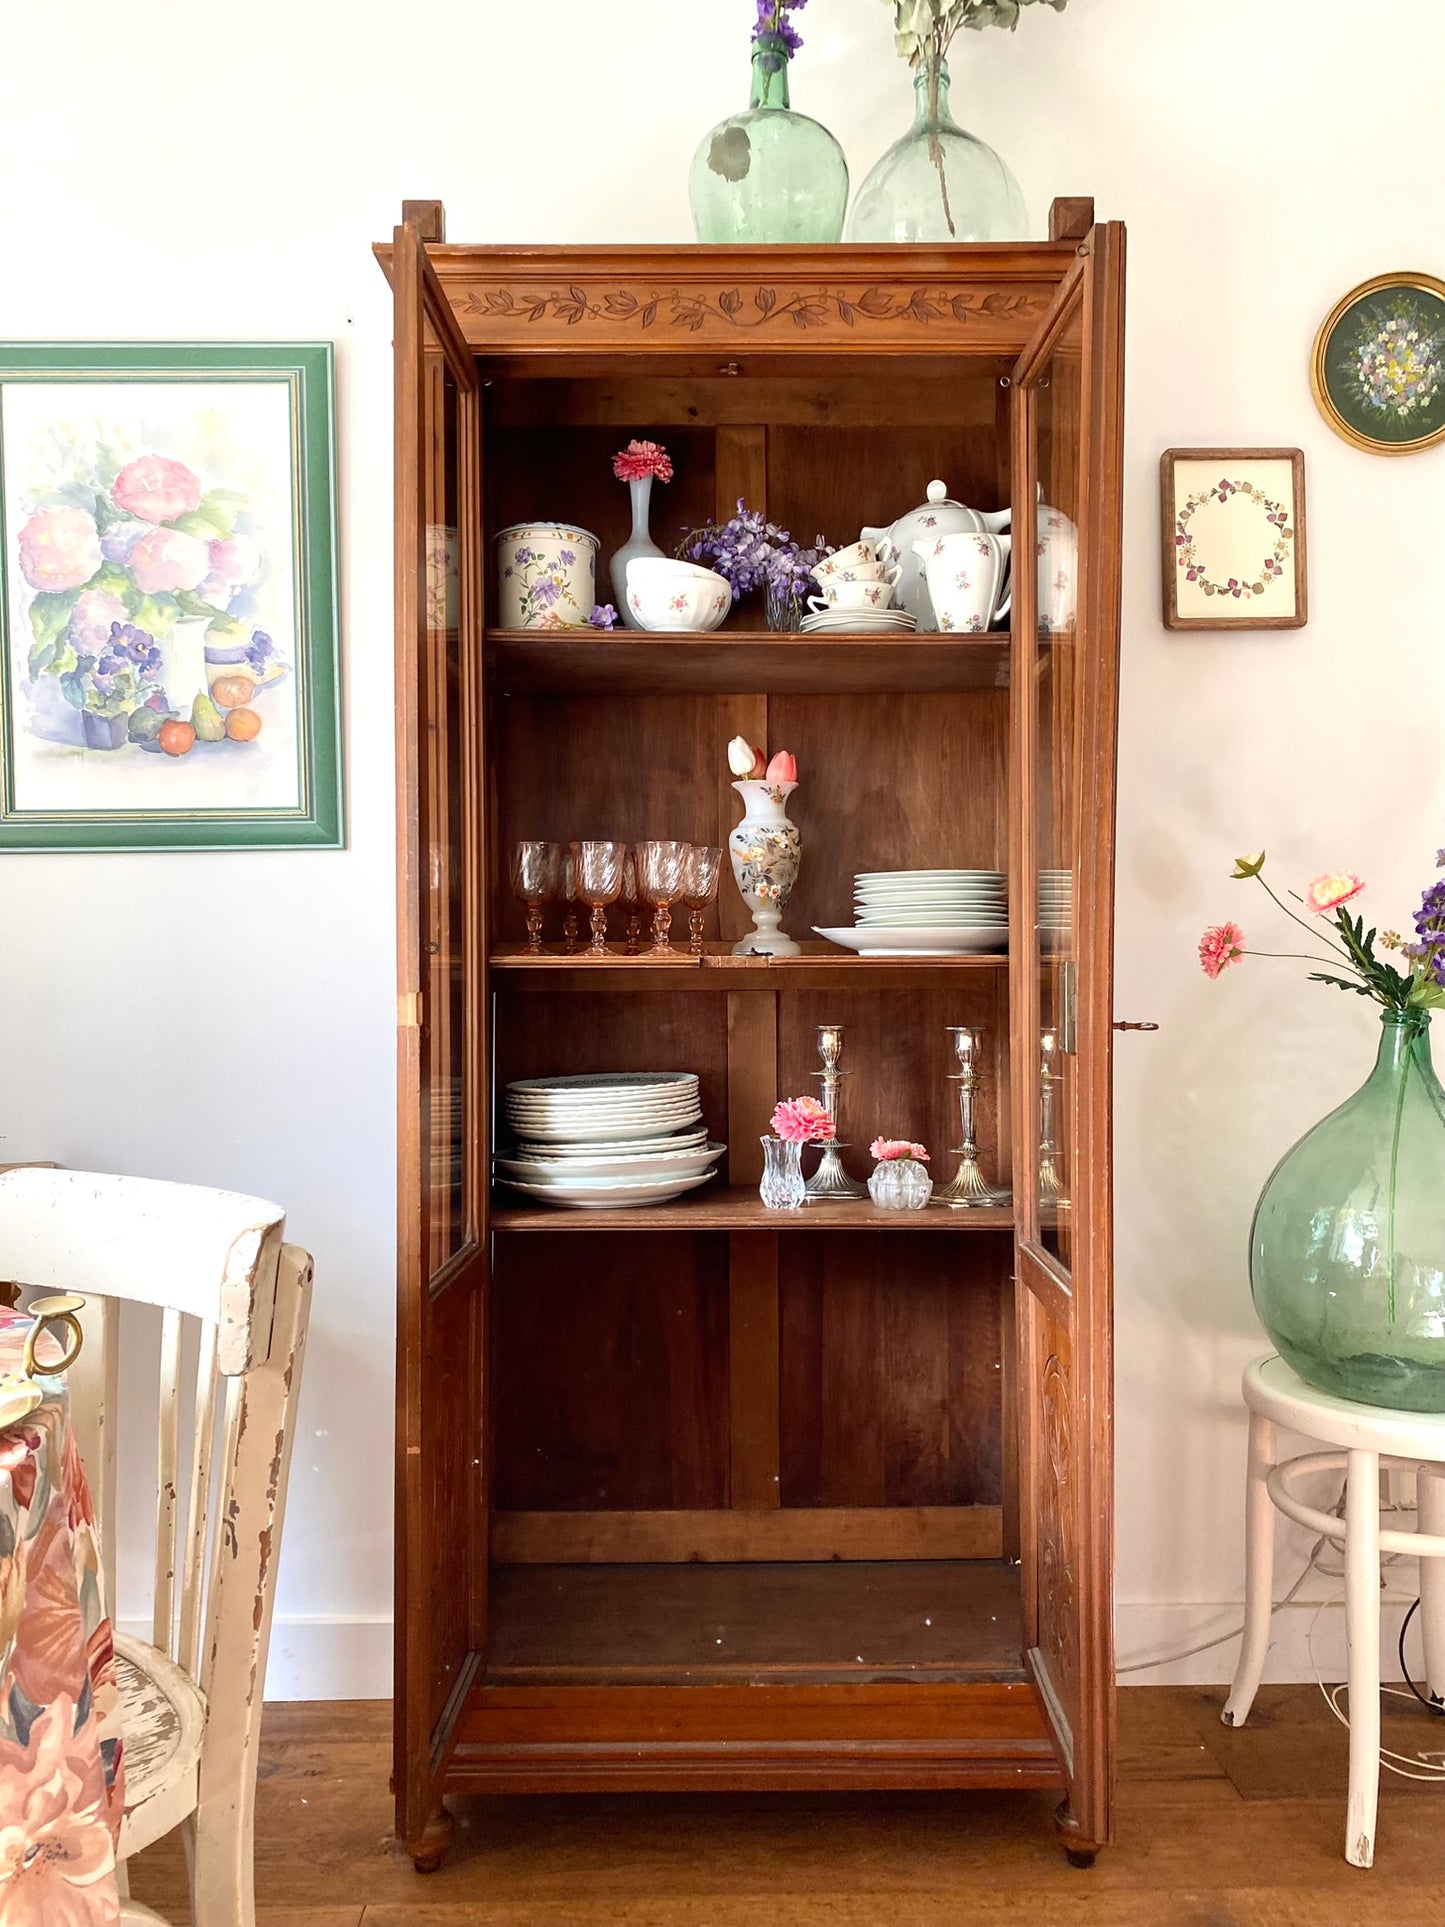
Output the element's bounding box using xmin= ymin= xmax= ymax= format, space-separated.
xmin=848 ymin=56 xmax=1029 ymax=241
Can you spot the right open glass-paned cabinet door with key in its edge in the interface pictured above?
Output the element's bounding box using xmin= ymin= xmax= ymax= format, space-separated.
xmin=1010 ymin=225 xmax=1123 ymax=1848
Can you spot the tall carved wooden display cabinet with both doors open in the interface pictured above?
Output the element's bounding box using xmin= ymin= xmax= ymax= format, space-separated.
xmin=378 ymin=200 xmax=1123 ymax=1867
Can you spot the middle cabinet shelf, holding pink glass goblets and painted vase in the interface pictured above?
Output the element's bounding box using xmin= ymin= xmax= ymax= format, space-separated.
xmin=489 ymin=942 xmax=1008 ymax=990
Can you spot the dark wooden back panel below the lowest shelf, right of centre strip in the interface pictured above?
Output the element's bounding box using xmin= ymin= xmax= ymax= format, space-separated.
xmin=778 ymin=1231 xmax=1010 ymax=1505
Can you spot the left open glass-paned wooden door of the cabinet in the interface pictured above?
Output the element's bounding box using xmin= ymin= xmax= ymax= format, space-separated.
xmin=391 ymin=224 xmax=487 ymax=1854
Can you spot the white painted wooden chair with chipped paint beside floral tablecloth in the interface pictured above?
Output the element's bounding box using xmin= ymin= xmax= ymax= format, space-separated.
xmin=0 ymin=1168 xmax=310 ymax=1927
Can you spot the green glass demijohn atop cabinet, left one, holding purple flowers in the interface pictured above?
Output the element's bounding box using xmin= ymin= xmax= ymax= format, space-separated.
xmin=688 ymin=33 xmax=848 ymax=243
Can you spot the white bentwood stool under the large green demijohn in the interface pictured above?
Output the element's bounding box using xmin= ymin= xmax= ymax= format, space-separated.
xmin=1222 ymin=1357 xmax=1445 ymax=1867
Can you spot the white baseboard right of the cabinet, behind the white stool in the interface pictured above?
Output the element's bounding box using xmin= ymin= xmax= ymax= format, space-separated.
xmin=1114 ymin=1586 xmax=1420 ymax=1686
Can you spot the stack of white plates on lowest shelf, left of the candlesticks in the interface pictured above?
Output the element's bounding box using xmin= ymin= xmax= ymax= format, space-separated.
xmin=497 ymin=1071 xmax=726 ymax=1210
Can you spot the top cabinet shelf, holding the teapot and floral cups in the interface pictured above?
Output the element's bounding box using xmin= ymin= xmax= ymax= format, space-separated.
xmin=486 ymin=628 xmax=1010 ymax=696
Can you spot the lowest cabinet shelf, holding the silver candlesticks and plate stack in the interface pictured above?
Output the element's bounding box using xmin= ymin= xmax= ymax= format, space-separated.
xmin=491 ymin=1185 xmax=1013 ymax=1233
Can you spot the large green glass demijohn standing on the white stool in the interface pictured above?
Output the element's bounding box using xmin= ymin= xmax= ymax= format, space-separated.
xmin=1250 ymin=1010 xmax=1445 ymax=1412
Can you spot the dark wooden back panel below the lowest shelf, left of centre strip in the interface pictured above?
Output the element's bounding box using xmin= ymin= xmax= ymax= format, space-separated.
xmin=491 ymin=1231 xmax=728 ymax=1511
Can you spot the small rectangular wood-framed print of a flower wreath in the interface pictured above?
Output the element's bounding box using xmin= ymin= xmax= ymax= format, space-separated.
xmin=1160 ymin=449 xmax=1308 ymax=628
